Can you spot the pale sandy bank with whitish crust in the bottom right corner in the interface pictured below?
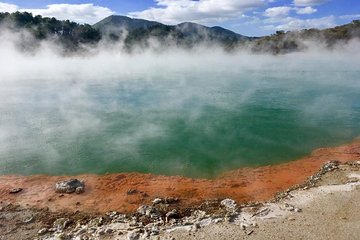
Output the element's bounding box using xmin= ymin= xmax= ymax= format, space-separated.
xmin=161 ymin=164 xmax=360 ymax=240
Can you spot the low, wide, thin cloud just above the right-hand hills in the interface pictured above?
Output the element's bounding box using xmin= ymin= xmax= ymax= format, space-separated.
xmin=264 ymin=15 xmax=336 ymax=31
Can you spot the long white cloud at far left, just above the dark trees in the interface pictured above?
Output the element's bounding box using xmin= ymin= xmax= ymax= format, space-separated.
xmin=0 ymin=2 xmax=114 ymax=24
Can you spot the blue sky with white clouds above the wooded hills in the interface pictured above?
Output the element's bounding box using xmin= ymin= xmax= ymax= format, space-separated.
xmin=0 ymin=0 xmax=360 ymax=36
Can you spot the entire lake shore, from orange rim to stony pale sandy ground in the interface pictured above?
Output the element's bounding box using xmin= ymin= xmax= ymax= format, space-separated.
xmin=0 ymin=140 xmax=360 ymax=239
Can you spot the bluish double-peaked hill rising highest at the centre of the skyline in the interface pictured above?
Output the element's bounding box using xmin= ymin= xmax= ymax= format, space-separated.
xmin=93 ymin=15 xmax=251 ymax=48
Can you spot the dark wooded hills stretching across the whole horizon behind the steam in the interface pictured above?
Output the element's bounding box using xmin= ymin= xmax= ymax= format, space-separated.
xmin=0 ymin=12 xmax=360 ymax=54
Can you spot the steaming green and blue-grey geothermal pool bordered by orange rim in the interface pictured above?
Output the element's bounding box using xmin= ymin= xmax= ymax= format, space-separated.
xmin=0 ymin=53 xmax=360 ymax=177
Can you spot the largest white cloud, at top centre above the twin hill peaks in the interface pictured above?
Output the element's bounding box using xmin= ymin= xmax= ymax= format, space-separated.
xmin=129 ymin=0 xmax=271 ymax=24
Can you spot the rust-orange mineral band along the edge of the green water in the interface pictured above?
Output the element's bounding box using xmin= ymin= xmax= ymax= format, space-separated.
xmin=0 ymin=140 xmax=360 ymax=213
